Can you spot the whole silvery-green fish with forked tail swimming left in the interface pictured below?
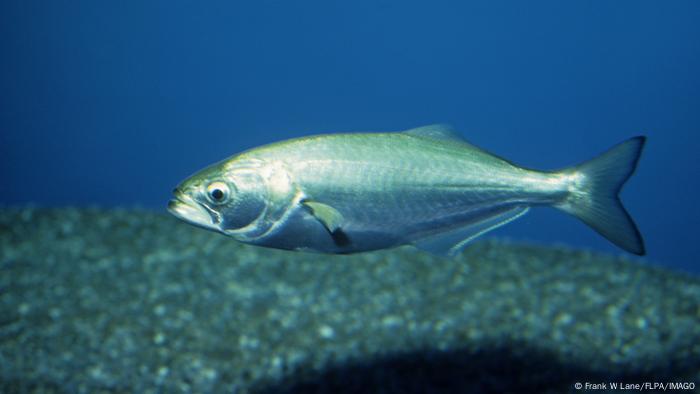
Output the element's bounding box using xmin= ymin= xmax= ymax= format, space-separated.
xmin=168 ymin=125 xmax=646 ymax=256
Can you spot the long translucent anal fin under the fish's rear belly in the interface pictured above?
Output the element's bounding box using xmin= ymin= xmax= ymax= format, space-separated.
xmin=414 ymin=207 xmax=530 ymax=257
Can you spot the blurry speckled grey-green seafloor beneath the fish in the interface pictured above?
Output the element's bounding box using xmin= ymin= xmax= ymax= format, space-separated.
xmin=0 ymin=208 xmax=700 ymax=393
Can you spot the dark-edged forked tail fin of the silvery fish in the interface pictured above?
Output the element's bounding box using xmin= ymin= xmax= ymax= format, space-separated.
xmin=557 ymin=137 xmax=646 ymax=256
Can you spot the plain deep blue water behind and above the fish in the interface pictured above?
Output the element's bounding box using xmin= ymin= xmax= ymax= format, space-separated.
xmin=0 ymin=1 xmax=700 ymax=272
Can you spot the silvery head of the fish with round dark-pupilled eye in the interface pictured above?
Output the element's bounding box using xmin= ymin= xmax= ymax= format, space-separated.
xmin=168 ymin=160 xmax=268 ymax=236
